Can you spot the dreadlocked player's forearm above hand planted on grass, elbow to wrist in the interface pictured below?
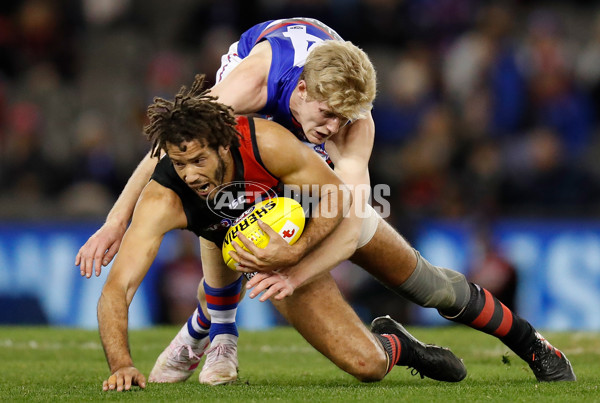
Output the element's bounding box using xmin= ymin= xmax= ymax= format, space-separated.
xmin=98 ymin=290 xmax=133 ymax=373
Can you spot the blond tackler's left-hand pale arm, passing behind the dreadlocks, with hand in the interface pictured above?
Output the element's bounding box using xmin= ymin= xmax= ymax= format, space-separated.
xmin=75 ymin=41 xmax=271 ymax=278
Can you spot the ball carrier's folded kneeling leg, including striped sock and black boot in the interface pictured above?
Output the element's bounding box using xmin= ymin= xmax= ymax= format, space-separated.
xmin=273 ymin=273 xmax=466 ymax=382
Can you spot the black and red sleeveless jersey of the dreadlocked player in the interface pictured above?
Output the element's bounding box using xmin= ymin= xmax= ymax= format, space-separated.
xmin=151 ymin=116 xmax=282 ymax=245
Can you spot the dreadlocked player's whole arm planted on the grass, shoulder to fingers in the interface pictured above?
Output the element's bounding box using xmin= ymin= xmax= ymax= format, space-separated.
xmin=98 ymin=181 xmax=187 ymax=391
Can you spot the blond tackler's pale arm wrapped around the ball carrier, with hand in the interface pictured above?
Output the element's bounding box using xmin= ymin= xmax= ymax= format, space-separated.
xmin=246 ymin=114 xmax=375 ymax=301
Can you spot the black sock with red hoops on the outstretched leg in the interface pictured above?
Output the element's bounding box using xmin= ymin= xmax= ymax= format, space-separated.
xmin=440 ymin=283 xmax=536 ymax=358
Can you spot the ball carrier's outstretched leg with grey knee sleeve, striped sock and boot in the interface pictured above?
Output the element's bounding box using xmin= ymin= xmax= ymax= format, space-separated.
xmin=351 ymin=219 xmax=576 ymax=381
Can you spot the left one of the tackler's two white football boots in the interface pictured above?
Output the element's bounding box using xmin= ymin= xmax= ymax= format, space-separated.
xmin=148 ymin=333 xmax=210 ymax=383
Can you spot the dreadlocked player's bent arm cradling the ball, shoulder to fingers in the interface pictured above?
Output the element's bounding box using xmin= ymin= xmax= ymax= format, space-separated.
xmin=231 ymin=119 xmax=352 ymax=271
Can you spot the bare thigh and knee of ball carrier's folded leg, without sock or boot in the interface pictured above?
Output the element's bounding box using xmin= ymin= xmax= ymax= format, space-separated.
xmin=272 ymin=273 xmax=388 ymax=382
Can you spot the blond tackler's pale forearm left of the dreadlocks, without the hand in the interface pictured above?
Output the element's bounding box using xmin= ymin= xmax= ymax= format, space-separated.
xmin=106 ymin=153 xmax=158 ymax=228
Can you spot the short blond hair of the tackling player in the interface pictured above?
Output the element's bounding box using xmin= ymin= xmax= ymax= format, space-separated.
xmin=300 ymin=40 xmax=377 ymax=120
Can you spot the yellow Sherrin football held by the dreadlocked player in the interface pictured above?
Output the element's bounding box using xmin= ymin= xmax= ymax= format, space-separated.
xmin=222 ymin=197 xmax=305 ymax=270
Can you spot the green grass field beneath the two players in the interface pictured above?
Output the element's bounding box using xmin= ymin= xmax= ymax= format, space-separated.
xmin=0 ymin=327 xmax=600 ymax=402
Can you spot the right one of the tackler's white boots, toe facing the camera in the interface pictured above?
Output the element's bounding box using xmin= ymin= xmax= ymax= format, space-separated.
xmin=200 ymin=334 xmax=238 ymax=385
